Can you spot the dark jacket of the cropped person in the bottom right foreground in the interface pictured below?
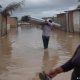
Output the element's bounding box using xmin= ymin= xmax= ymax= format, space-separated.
xmin=61 ymin=45 xmax=80 ymax=80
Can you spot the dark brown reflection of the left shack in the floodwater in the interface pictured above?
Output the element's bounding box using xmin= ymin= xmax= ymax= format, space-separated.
xmin=0 ymin=37 xmax=11 ymax=75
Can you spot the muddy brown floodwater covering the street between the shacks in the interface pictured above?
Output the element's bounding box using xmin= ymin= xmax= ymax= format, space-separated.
xmin=0 ymin=27 xmax=80 ymax=80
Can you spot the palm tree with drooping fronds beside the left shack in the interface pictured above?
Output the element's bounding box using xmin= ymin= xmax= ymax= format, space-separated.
xmin=1 ymin=1 xmax=23 ymax=35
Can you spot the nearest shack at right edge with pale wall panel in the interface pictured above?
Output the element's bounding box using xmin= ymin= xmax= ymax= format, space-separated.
xmin=67 ymin=8 xmax=80 ymax=32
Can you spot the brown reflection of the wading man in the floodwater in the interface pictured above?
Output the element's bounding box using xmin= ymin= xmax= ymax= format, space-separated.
xmin=43 ymin=50 xmax=58 ymax=72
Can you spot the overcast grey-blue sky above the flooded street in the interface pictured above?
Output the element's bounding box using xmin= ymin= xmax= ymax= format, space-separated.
xmin=0 ymin=0 xmax=78 ymax=18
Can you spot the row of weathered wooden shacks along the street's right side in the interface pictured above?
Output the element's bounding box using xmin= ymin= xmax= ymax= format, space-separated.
xmin=57 ymin=6 xmax=80 ymax=32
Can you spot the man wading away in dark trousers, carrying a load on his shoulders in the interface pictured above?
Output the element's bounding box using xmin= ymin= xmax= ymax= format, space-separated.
xmin=42 ymin=20 xmax=53 ymax=49
